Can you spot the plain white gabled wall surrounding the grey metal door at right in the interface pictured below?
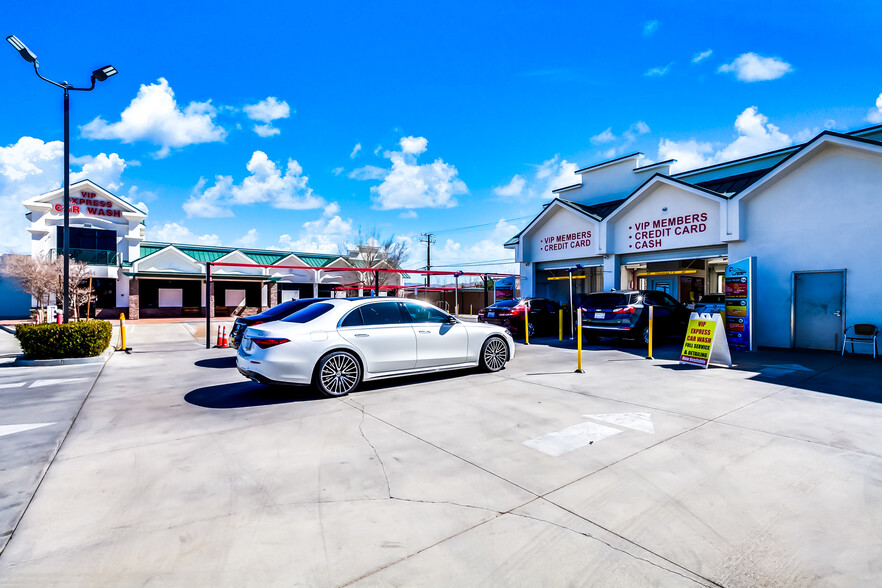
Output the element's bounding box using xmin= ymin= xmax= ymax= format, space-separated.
xmin=729 ymin=146 xmax=882 ymax=347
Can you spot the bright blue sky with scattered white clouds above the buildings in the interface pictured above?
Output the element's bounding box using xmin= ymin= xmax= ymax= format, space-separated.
xmin=0 ymin=1 xmax=882 ymax=271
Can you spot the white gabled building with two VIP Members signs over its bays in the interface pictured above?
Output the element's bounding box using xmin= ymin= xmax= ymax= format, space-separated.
xmin=505 ymin=125 xmax=882 ymax=350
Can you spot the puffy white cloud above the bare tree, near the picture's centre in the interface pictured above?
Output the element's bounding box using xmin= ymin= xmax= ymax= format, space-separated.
xmin=349 ymin=137 xmax=468 ymax=210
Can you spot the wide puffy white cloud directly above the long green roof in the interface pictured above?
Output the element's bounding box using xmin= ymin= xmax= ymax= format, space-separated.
xmin=184 ymin=151 xmax=325 ymax=217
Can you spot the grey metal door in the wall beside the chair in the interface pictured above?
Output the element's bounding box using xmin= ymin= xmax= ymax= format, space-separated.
xmin=793 ymin=270 xmax=845 ymax=351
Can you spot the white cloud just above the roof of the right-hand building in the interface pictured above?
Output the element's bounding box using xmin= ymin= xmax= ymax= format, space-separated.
xmin=658 ymin=106 xmax=794 ymax=172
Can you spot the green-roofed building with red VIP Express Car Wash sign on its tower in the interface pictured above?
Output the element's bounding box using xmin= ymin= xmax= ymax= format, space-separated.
xmin=23 ymin=180 xmax=401 ymax=319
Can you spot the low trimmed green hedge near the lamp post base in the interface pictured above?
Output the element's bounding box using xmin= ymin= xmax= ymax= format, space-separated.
xmin=15 ymin=320 xmax=111 ymax=359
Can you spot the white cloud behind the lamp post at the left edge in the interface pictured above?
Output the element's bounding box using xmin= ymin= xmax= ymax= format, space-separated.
xmin=0 ymin=137 xmax=129 ymax=253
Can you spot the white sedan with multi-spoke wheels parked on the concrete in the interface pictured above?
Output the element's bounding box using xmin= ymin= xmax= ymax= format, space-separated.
xmin=236 ymin=298 xmax=514 ymax=396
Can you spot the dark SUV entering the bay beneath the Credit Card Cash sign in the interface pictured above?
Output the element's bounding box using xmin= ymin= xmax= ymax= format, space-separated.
xmin=581 ymin=290 xmax=690 ymax=343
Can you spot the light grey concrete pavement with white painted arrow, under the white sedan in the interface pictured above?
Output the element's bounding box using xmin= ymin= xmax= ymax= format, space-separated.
xmin=0 ymin=325 xmax=882 ymax=586
